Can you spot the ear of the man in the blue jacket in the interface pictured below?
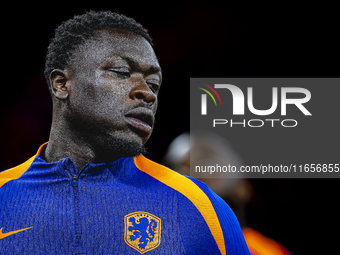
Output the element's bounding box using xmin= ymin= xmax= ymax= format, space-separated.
xmin=50 ymin=69 xmax=69 ymax=99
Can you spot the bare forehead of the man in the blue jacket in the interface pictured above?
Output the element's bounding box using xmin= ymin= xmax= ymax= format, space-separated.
xmin=71 ymin=28 xmax=160 ymax=70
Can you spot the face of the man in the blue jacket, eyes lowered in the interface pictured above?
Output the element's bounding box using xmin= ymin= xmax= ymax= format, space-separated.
xmin=67 ymin=29 xmax=162 ymax=156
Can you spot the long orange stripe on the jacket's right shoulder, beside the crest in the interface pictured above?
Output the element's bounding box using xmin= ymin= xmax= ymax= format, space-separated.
xmin=134 ymin=155 xmax=227 ymax=255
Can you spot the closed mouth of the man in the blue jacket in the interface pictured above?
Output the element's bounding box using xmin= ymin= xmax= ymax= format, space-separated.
xmin=125 ymin=107 xmax=154 ymax=137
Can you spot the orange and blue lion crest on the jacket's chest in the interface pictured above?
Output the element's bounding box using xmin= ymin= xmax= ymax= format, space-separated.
xmin=124 ymin=212 xmax=161 ymax=254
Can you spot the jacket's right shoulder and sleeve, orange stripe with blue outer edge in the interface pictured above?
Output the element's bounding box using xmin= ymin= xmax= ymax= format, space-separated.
xmin=134 ymin=156 xmax=249 ymax=255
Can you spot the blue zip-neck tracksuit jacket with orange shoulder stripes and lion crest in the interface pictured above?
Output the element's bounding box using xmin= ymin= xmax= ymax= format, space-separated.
xmin=0 ymin=144 xmax=249 ymax=255
